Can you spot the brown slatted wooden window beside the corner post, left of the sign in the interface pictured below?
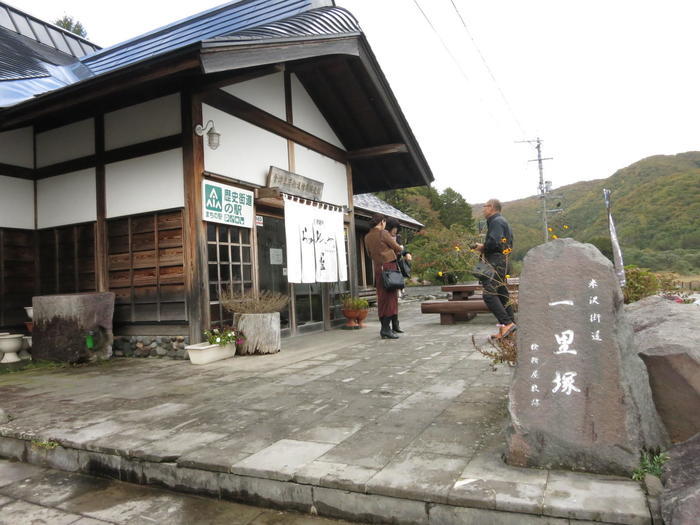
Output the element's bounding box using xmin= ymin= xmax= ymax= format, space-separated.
xmin=107 ymin=210 xmax=187 ymax=324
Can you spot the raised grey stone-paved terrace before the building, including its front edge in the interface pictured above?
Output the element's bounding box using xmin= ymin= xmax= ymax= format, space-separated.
xmin=0 ymin=302 xmax=651 ymax=525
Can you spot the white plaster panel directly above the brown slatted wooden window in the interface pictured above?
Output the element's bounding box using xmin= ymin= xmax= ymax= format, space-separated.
xmin=105 ymin=148 xmax=185 ymax=218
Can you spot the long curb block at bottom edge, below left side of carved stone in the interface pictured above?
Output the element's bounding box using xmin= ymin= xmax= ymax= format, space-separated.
xmin=429 ymin=505 xmax=572 ymax=525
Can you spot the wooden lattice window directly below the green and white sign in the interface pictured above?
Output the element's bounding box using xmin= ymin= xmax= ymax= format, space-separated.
xmin=207 ymin=222 xmax=253 ymax=325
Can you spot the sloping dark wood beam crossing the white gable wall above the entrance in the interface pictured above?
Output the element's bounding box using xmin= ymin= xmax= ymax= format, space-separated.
xmin=201 ymin=89 xmax=347 ymax=163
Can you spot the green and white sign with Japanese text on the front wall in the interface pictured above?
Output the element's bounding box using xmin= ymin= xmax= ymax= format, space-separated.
xmin=202 ymin=180 xmax=253 ymax=228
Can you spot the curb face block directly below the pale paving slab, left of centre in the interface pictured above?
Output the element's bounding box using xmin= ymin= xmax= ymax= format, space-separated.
xmin=219 ymin=474 xmax=314 ymax=513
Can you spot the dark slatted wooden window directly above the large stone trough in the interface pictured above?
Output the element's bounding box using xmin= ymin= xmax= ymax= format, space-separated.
xmin=39 ymin=222 xmax=97 ymax=295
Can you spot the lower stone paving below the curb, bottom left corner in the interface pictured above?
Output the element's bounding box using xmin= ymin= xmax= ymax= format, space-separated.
xmin=0 ymin=460 xmax=349 ymax=525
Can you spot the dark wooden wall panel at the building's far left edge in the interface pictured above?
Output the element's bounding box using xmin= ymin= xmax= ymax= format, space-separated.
xmin=0 ymin=228 xmax=35 ymax=327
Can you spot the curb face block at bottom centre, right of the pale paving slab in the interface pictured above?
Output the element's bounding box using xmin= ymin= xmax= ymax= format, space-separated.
xmin=313 ymin=487 xmax=429 ymax=525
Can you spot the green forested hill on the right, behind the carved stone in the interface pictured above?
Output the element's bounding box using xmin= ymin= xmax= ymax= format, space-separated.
xmin=492 ymin=151 xmax=700 ymax=272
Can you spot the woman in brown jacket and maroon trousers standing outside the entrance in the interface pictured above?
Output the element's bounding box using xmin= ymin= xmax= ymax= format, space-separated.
xmin=365 ymin=213 xmax=403 ymax=339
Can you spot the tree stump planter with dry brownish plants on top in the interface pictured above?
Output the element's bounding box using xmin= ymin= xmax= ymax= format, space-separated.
xmin=219 ymin=289 xmax=289 ymax=355
